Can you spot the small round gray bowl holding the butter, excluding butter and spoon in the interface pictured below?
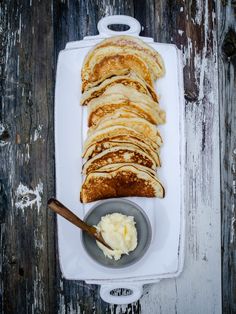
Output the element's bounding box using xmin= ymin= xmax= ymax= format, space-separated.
xmin=82 ymin=198 xmax=152 ymax=269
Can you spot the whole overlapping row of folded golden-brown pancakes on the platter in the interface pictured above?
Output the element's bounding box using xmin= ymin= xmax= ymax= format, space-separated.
xmin=80 ymin=36 xmax=165 ymax=203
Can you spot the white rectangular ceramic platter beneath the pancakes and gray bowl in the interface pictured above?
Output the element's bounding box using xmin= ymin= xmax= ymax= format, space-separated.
xmin=55 ymin=17 xmax=184 ymax=303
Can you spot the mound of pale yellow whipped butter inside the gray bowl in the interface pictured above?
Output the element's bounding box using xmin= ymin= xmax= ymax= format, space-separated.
xmin=96 ymin=213 xmax=137 ymax=260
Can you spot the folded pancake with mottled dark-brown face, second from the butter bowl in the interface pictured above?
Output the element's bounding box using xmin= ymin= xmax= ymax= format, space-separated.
xmin=83 ymin=145 xmax=156 ymax=174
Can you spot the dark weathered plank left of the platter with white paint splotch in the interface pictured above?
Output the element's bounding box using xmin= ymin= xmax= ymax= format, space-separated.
xmin=0 ymin=1 xmax=56 ymax=314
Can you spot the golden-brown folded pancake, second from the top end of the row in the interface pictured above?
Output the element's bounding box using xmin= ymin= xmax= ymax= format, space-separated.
xmin=81 ymin=49 xmax=153 ymax=92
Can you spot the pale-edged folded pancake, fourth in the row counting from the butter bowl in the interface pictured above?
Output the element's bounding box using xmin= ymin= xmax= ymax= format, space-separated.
xmin=84 ymin=125 xmax=162 ymax=151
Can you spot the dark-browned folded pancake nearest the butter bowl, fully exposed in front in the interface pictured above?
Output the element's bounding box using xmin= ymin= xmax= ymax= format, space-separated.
xmin=80 ymin=164 xmax=165 ymax=203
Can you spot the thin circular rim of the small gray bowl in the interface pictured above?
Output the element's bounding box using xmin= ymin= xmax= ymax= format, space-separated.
xmin=81 ymin=198 xmax=152 ymax=270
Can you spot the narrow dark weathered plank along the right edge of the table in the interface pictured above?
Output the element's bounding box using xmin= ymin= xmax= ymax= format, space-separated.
xmin=218 ymin=1 xmax=236 ymax=313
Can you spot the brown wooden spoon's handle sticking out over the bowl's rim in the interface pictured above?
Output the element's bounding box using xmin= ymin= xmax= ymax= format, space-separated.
xmin=48 ymin=198 xmax=97 ymax=235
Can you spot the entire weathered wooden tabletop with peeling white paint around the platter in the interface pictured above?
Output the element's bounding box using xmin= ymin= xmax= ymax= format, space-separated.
xmin=0 ymin=0 xmax=236 ymax=314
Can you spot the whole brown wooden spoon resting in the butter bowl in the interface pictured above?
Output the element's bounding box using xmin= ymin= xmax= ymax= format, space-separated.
xmin=48 ymin=198 xmax=112 ymax=250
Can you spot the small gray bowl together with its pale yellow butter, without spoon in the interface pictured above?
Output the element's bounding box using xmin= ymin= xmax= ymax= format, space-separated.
xmin=82 ymin=198 xmax=152 ymax=269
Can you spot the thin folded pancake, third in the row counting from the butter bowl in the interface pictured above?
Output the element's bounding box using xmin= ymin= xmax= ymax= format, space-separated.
xmin=83 ymin=136 xmax=161 ymax=167
